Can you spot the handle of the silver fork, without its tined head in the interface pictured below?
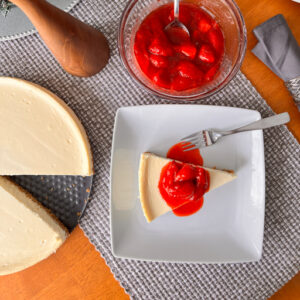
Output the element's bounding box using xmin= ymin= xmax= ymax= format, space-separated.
xmin=223 ymin=112 xmax=290 ymax=135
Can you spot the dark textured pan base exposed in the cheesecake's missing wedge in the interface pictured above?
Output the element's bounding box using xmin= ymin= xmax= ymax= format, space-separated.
xmin=12 ymin=176 xmax=93 ymax=231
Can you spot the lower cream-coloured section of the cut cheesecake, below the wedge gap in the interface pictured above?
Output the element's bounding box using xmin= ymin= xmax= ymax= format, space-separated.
xmin=0 ymin=176 xmax=68 ymax=275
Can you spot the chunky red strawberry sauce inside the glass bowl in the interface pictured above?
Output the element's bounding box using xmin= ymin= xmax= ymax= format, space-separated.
xmin=134 ymin=3 xmax=224 ymax=91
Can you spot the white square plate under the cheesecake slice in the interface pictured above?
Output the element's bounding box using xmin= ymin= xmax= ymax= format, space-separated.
xmin=111 ymin=105 xmax=265 ymax=263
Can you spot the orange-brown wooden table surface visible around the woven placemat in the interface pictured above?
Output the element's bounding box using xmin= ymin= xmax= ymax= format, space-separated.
xmin=0 ymin=0 xmax=300 ymax=300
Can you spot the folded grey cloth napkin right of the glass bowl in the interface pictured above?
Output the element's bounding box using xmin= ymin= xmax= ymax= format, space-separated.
xmin=252 ymin=15 xmax=300 ymax=108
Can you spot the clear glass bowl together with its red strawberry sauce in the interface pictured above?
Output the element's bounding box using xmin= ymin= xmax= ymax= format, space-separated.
xmin=118 ymin=0 xmax=246 ymax=100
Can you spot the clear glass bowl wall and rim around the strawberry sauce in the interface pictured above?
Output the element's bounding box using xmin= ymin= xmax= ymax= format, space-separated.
xmin=118 ymin=0 xmax=247 ymax=100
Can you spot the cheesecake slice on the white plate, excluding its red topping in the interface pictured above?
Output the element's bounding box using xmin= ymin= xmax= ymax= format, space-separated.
xmin=139 ymin=153 xmax=236 ymax=222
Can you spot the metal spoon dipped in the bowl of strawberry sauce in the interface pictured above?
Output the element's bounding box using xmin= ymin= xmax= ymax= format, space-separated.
xmin=165 ymin=0 xmax=190 ymax=44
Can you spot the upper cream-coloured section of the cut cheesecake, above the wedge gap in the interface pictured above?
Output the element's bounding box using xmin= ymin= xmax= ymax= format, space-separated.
xmin=0 ymin=77 xmax=93 ymax=176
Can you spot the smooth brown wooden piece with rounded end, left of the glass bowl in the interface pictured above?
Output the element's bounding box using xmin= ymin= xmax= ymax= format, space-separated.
xmin=11 ymin=0 xmax=109 ymax=77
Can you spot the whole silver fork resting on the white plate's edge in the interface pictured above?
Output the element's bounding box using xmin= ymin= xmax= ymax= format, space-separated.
xmin=181 ymin=113 xmax=290 ymax=151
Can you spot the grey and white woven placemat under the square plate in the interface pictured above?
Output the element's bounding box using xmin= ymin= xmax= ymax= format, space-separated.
xmin=0 ymin=0 xmax=300 ymax=300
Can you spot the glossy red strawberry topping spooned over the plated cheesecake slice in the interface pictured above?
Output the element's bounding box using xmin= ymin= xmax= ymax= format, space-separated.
xmin=158 ymin=144 xmax=209 ymax=216
